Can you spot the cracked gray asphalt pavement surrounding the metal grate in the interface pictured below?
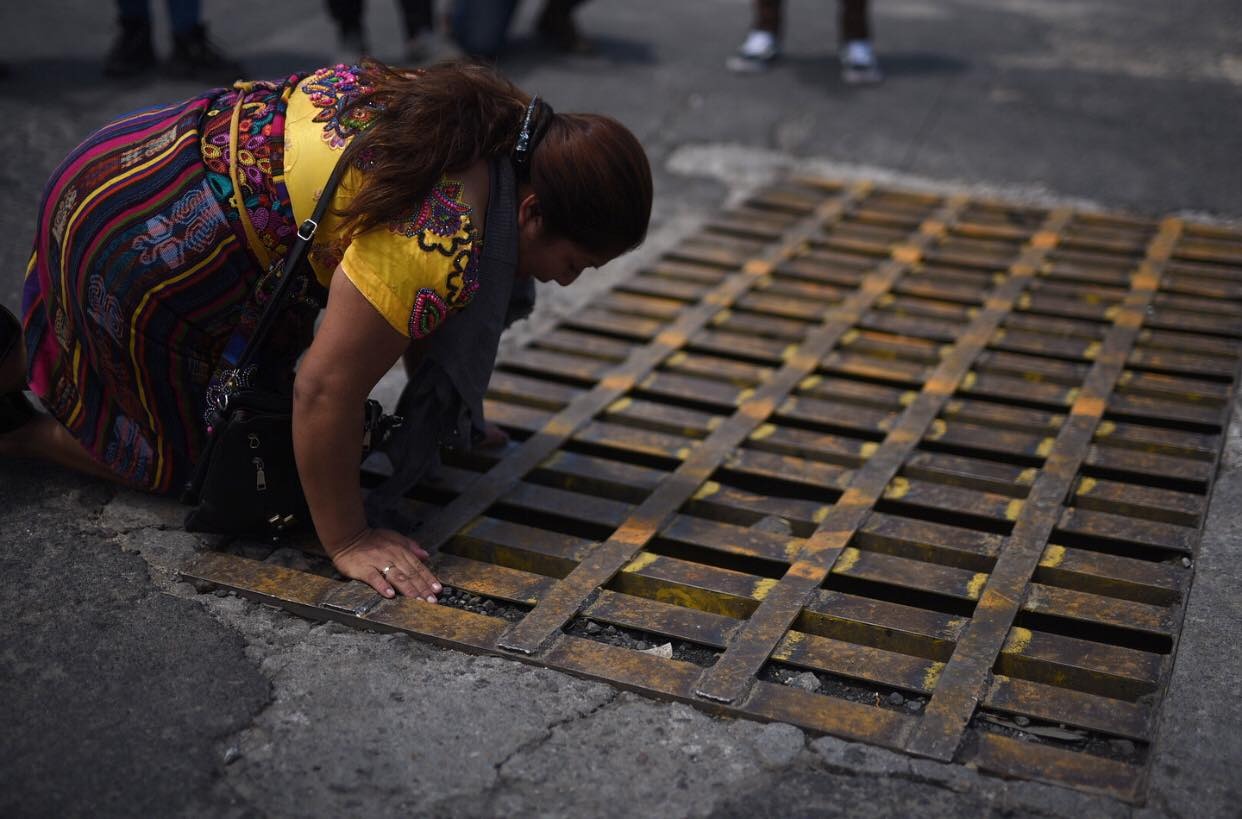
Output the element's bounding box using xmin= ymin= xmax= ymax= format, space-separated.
xmin=0 ymin=0 xmax=1242 ymax=818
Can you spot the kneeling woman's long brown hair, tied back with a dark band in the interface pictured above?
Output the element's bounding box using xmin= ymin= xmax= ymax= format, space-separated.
xmin=342 ymin=61 xmax=652 ymax=255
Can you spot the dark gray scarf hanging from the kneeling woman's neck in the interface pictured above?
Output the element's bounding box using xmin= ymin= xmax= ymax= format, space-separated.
xmin=366 ymin=158 xmax=534 ymax=528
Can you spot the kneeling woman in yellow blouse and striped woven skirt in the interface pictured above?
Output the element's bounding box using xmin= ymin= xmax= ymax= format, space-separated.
xmin=0 ymin=61 xmax=652 ymax=602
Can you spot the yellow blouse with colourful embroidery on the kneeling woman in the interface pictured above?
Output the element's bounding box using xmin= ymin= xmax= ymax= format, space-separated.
xmin=284 ymin=67 xmax=482 ymax=339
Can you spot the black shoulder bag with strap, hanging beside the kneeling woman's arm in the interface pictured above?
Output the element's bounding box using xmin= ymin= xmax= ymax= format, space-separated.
xmin=181 ymin=157 xmax=400 ymax=538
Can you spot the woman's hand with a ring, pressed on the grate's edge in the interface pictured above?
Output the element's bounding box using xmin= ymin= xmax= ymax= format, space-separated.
xmin=332 ymin=528 xmax=443 ymax=603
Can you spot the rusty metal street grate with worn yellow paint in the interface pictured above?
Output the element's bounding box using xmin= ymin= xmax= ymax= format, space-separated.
xmin=186 ymin=178 xmax=1242 ymax=802
